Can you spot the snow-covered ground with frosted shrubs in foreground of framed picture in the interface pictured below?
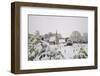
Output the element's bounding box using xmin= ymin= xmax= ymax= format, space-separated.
xmin=28 ymin=41 xmax=88 ymax=61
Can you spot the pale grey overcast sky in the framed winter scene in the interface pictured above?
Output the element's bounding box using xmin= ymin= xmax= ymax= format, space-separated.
xmin=28 ymin=15 xmax=88 ymax=36
